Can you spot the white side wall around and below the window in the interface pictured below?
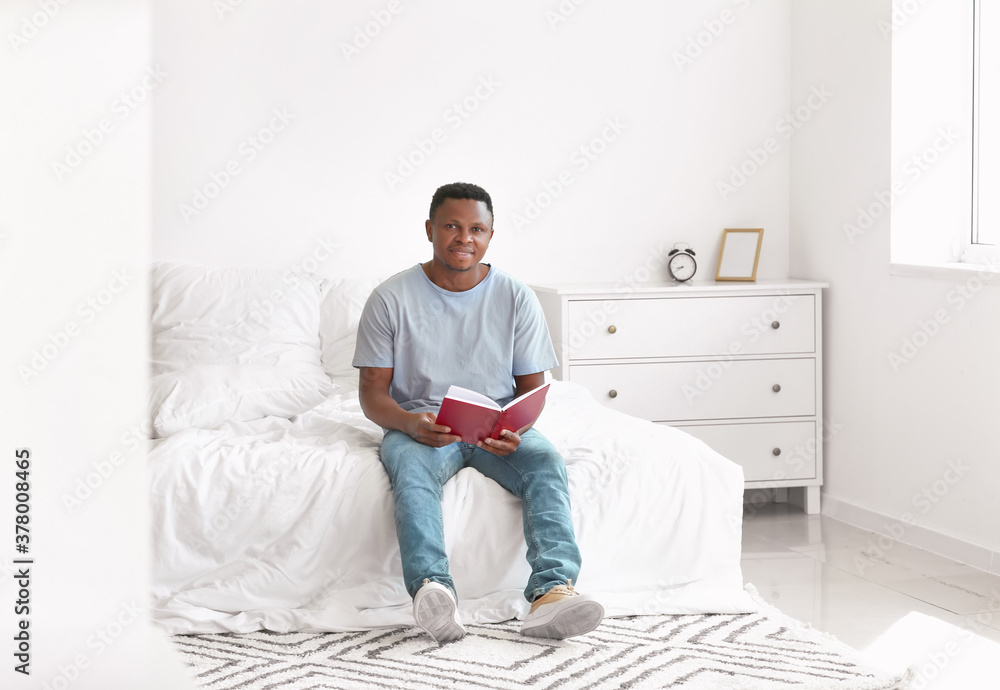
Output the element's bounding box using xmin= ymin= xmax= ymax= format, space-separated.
xmin=789 ymin=0 xmax=1000 ymax=572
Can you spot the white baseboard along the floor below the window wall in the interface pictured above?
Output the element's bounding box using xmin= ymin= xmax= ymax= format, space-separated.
xmin=822 ymin=493 xmax=1000 ymax=575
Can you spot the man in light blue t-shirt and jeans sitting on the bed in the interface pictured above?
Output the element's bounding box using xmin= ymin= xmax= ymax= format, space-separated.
xmin=354 ymin=182 xmax=604 ymax=644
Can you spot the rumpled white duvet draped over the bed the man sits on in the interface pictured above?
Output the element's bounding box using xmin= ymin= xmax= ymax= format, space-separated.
xmin=149 ymin=378 xmax=756 ymax=633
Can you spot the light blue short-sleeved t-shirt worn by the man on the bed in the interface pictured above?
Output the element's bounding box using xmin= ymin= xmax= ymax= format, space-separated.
xmin=353 ymin=264 xmax=558 ymax=412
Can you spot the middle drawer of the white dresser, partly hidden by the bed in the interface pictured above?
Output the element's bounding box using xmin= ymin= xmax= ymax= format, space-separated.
xmin=569 ymin=358 xmax=816 ymax=422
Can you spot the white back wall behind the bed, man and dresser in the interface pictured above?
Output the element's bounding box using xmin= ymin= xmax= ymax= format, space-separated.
xmin=152 ymin=0 xmax=788 ymax=281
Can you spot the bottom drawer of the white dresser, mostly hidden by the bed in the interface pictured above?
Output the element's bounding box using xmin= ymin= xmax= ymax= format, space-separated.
xmin=677 ymin=422 xmax=817 ymax=482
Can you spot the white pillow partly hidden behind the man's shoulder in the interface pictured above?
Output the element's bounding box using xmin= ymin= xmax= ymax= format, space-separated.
xmin=320 ymin=278 xmax=384 ymax=379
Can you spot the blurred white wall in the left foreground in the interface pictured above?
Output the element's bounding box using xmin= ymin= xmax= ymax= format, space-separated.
xmin=0 ymin=0 xmax=194 ymax=690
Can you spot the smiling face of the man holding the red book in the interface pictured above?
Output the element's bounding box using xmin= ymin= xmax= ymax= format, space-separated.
xmin=425 ymin=199 xmax=493 ymax=271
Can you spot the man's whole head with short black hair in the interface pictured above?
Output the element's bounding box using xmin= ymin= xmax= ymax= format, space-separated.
xmin=424 ymin=182 xmax=493 ymax=277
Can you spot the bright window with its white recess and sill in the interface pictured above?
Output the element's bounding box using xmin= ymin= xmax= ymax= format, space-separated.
xmin=882 ymin=0 xmax=1000 ymax=277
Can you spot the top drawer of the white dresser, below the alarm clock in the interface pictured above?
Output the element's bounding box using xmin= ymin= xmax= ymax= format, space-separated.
xmin=564 ymin=295 xmax=816 ymax=359
